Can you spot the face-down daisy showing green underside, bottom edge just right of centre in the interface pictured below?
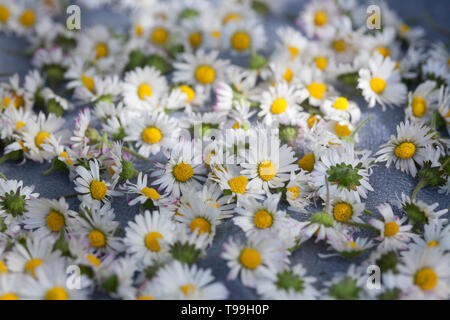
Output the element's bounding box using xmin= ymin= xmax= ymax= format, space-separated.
xmin=256 ymin=263 xmax=319 ymax=300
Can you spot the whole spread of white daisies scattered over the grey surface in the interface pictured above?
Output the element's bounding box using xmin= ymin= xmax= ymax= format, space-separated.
xmin=0 ymin=0 xmax=450 ymax=299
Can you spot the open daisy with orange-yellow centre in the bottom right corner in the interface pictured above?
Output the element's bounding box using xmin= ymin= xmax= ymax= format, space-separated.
xmin=398 ymin=248 xmax=450 ymax=300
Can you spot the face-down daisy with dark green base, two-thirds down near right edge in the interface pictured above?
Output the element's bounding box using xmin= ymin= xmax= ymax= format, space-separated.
xmin=397 ymin=192 xmax=448 ymax=224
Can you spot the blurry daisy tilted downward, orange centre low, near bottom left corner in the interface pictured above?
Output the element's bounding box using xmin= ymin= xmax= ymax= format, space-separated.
xmin=5 ymin=232 xmax=61 ymax=277
